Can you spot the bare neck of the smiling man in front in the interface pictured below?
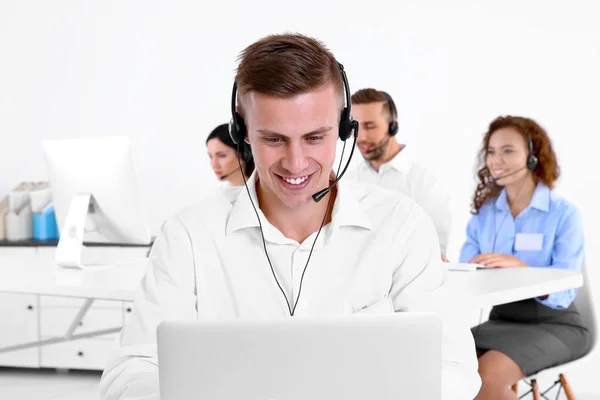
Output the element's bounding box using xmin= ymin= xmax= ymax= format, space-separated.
xmin=256 ymin=180 xmax=337 ymax=243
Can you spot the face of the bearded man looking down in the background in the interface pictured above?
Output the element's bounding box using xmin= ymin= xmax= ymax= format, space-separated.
xmin=352 ymin=101 xmax=390 ymax=160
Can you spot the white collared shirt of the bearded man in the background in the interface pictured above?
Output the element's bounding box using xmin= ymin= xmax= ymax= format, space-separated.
xmin=346 ymin=146 xmax=452 ymax=254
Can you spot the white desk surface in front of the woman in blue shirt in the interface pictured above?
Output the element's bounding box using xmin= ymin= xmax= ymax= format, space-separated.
xmin=410 ymin=267 xmax=583 ymax=312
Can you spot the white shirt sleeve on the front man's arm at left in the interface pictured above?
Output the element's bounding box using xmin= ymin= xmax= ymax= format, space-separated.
xmin=99 ymin=218 xmax=197 ymax=400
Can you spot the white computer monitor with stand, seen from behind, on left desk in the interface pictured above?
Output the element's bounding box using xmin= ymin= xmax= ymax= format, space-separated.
xmin=42 ymin=137 xmax=152 ymax=267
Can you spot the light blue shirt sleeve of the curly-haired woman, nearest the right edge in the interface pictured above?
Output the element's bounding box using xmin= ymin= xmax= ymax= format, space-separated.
xmin=536 ymin=206 xmax=585 ymax=309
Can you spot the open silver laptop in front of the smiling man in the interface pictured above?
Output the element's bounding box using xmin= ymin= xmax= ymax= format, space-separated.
xmin=157 ymin=313 xmax=441 ymax=400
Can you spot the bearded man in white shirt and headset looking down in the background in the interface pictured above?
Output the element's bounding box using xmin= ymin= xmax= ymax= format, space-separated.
xmin=348 ymin=89 xmax=452 ymax=261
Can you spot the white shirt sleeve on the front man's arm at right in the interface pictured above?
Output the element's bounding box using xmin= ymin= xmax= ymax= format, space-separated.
xmin=390 ymin=203 xmax=481 ymax=400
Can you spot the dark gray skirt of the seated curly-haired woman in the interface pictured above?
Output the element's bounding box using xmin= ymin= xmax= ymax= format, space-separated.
xmin=471 ymin=299 xmax=590 ymax=376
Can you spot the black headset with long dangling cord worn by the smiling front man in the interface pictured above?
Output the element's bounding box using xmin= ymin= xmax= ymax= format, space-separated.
xmin=229 ymin=63 xmax=358 ymax=316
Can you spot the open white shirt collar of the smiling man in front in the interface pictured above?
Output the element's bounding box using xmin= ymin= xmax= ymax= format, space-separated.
xmin=225 ymin=171 xmax=373 ymax=235
